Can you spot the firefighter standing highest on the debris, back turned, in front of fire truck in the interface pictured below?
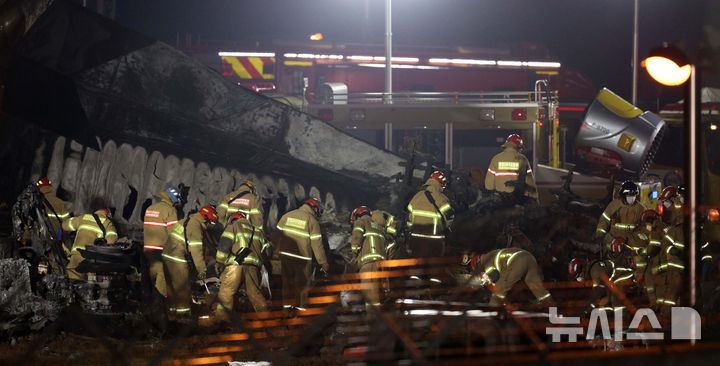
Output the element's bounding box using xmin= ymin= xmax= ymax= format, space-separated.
xmin=485 ymin=134 xmax=538 ymax=200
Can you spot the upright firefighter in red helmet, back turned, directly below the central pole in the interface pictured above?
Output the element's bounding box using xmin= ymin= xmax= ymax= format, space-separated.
xmin=407 ymin=171 xmax=455 ymax=258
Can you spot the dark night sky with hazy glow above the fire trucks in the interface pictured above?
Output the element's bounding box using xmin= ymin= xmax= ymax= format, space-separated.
xmin=118 ymin=0 xmax=703 ymax=103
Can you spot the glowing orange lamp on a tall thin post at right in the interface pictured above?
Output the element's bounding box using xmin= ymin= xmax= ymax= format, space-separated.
xmin=642 ymin=43 xmax=700 ymax=338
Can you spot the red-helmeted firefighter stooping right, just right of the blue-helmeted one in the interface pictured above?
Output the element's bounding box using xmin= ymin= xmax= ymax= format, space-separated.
xmin=162 ymin=205 xmax=218 ymax=319
